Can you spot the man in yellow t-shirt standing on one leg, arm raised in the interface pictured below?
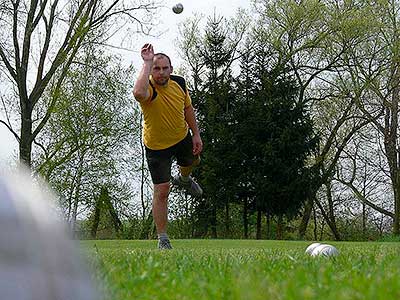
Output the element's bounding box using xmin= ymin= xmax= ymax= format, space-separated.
xmin=133 ymin=44 xmax=203 ymax=249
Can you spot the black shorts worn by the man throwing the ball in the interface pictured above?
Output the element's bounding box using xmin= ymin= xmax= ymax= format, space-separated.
xmin=145 ymin=132 xmax=197 ymax=184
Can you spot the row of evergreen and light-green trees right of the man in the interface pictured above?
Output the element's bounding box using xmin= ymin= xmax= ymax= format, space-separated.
xmin=80 ymin=1 xmax=400 ymax=240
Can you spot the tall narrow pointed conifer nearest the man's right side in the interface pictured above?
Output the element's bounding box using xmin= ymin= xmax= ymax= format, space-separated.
xmin=184 ymin=15 xmax=244 ymax=236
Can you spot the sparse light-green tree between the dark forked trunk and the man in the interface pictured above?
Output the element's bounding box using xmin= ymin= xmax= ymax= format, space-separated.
xmin=34 ymin=47 xmax=139 ymax=230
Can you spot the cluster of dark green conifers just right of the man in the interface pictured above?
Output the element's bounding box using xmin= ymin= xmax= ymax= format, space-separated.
xmin=179 ymin=5 xmax=316 ymax=237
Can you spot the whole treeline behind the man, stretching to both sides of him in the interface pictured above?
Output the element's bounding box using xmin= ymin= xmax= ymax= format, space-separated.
xmin=0 ymin=0 xmax=400 ymax=240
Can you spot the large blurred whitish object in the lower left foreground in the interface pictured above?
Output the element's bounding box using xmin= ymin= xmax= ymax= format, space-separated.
xmin=0 ymin=171 xmax=99 ymax=300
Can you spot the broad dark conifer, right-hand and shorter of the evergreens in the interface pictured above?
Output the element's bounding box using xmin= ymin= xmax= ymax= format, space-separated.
xmin=236 ymin=66 xmax=317 ymax=216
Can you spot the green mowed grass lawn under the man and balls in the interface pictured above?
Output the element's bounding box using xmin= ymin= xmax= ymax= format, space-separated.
xmin=81 ymin=240 xmax=400 ymax=300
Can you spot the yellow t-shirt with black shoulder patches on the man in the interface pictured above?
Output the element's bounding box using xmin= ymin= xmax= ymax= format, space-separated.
xmin=140 ymin=75 xmax=192 ymax=150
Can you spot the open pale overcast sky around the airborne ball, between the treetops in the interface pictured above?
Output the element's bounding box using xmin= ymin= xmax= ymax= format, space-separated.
xmin=0 ymin=0 xmax=251 ymax=167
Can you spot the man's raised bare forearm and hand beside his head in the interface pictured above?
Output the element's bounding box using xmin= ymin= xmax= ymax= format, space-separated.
xmin=133 ymin=44 xmax=154 ymax=101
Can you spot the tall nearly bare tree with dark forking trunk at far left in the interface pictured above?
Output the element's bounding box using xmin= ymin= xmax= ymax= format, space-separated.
xmin=0 ymin=0 xmax=158 ymax=167
